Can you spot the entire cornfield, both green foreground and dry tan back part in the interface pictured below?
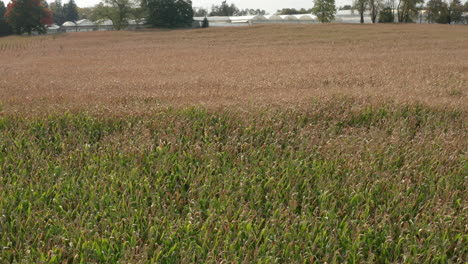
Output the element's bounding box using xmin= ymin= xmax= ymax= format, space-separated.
xmin=0 ymin=24 xmax=468 ymax=263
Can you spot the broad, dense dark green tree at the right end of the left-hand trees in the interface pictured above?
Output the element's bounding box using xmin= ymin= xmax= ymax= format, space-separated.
xmin=147 ymin=0 xmax=193 ymax=28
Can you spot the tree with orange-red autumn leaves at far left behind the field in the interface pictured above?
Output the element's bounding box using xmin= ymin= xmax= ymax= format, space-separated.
xmin=5 ymin=0 xmax=53 ymax=35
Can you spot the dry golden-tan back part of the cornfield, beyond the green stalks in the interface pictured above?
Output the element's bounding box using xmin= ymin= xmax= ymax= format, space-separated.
xmin=0 ymin=24 xmax=468 ymax=112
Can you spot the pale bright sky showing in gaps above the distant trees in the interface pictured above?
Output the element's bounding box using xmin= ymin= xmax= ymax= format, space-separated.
xmin=72 ymin=0 xmax=352 ymax=14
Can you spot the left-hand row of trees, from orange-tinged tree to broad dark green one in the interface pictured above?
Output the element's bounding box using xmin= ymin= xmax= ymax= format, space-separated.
xmin=0 ymin=0 xmax=193 ymax=36
